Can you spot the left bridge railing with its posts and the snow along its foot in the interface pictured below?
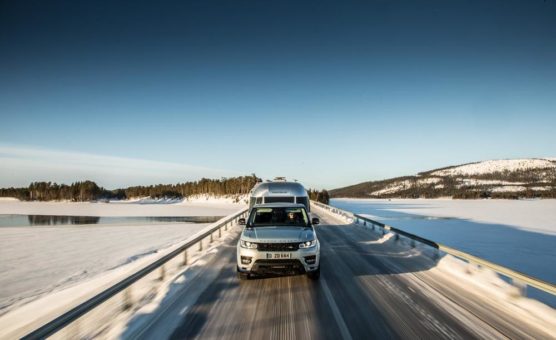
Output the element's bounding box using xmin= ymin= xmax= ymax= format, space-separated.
xmin=21 ymin=209 xmax=247 ymax=339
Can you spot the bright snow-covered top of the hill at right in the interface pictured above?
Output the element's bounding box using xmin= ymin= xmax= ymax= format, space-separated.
xmin=432 ymin=159 xmax=556 ymax=176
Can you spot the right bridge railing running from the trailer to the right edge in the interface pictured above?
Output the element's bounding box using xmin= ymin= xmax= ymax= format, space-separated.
xmin=311 ymin=201 xmax=556 ymax=295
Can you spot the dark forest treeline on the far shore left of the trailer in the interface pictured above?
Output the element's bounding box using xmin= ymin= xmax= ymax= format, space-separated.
xmin=0 ymin=174 xmax=260 ymax=202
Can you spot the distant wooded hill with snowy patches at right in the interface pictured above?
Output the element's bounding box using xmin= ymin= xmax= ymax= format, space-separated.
xmin=330 ymin=158 xmax=556 ymax=199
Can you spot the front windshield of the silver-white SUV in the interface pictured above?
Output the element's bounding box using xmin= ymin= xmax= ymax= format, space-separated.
xmin=249 ymin=208 xmax=309 ymax=227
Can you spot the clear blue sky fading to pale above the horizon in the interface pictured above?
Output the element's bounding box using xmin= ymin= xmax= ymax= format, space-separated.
xmin=0 ymin=1 xmax=556 ymax=189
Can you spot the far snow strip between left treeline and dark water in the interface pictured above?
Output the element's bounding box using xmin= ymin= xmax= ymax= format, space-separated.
xmin=0 ymin=197 xmax=244 ymax=217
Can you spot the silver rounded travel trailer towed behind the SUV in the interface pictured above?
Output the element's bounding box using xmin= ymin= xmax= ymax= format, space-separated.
xmin=249 ymin=177 xmax=310 ymax=212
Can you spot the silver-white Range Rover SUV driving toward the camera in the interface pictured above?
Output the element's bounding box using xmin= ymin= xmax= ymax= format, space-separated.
xmin=237 ymin=203 xmax=320 ymax=280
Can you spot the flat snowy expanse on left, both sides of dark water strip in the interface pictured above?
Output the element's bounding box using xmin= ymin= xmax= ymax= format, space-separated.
xmin=0 ymin=198 xmax=244 ymax=315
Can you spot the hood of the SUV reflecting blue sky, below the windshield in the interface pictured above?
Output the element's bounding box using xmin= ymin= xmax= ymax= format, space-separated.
xmin=241 ymin=227 xmax=315 ymax=243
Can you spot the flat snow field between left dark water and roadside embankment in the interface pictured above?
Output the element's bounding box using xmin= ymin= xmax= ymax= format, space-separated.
xmin=0 ymin=223 xmax=207 ymax=315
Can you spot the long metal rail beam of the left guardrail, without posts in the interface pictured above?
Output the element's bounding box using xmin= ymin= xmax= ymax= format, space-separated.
xmin=22 ymin=208 xmax=248 ymax=340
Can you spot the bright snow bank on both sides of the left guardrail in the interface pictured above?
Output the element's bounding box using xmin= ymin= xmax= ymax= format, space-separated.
xmin=0 ymin=208 xmax=242 ymax=339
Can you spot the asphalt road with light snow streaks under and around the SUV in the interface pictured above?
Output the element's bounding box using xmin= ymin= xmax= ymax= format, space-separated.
xmin=129 ymin=209 xmax=554 ymax=339
